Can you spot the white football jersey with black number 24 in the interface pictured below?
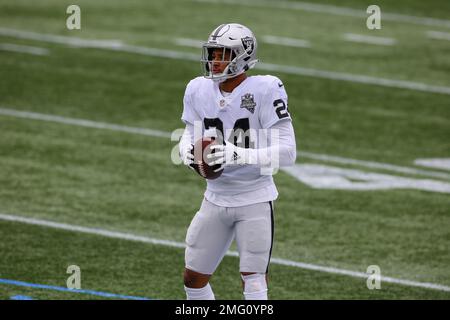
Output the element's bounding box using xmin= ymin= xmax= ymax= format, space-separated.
xmin=181 ymin=75 xmax=291 ymax=207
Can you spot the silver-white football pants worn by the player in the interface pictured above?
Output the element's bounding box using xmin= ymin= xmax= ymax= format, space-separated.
xmin=185 ymin=199 xmax=273 ymax=274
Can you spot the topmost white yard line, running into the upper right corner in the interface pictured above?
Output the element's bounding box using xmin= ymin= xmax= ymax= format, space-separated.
xmin=193 ymin=0 xmax=450 ymax=28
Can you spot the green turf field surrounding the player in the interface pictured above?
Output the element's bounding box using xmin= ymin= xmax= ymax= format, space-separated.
xmin=0 ymin=0 xmax=450 ymax=299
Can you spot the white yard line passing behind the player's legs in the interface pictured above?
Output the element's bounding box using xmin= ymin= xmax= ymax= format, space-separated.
xmin=0 ymin=213 xmax=450 ymax=292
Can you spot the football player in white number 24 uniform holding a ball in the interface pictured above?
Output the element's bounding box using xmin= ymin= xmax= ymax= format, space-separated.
xmin=180 ymin=23 xmax=296 ymax=300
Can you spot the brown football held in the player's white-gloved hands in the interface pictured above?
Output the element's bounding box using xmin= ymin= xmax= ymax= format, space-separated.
xmin=191 ymin=138 xmax=223 ymax=180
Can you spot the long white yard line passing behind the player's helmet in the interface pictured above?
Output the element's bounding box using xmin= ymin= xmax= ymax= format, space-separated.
xmin=0 ymin=28 xmax=450 ymax=95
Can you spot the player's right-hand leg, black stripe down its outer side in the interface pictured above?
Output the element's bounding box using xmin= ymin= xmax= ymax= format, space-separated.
xmin=236 ymin=202 xmax=273 ymax=300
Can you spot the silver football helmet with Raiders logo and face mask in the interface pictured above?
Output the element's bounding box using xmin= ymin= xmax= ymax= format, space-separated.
xmin=201 ymin=23 xmax=258 ymax=82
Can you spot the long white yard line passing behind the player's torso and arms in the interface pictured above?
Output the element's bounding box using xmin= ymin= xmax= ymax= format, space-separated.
xmin=0 ymin=106 xmax=450 ymax=179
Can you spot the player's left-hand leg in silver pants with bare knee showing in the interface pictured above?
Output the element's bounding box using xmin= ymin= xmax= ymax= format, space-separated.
xmin=184 ymin=199 xmax=234 ymax=300
